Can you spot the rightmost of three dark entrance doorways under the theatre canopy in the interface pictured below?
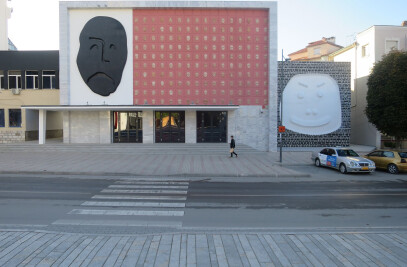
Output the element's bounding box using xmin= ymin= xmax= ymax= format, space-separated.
xmin=196 ymin=111 xmax=227 ymax=143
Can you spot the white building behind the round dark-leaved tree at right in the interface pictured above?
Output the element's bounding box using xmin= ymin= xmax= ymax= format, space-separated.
xmin=330 ymin=24 xmax=407 ymax=148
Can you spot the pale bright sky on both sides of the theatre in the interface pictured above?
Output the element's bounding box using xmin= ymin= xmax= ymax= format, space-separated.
xmin=4 ymin=0 xmax=407 ymax=60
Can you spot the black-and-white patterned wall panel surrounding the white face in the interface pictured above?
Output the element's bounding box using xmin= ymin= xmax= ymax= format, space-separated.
xmin=276 ymin=61 xmax=351 ymax=147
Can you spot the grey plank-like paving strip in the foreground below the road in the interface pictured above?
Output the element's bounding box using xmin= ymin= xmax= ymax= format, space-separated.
xmin=0 ymin=231 xmax=407 ymax=267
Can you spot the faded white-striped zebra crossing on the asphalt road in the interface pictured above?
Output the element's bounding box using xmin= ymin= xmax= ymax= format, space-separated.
xmin=53 ymin=179 xmax=189 ymax=227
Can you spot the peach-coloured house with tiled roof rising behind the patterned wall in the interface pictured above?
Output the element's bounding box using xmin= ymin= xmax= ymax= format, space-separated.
xmin=288 ymin=37 xmax=342 ymax=61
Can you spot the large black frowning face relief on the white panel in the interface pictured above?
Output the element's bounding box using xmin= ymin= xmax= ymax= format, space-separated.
xmin=76 ymin=17 xmax=127 ymax=96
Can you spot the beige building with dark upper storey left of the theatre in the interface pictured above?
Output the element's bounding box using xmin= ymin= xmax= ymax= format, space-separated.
xmin=0 ymin=51 xmax=62 ymax=143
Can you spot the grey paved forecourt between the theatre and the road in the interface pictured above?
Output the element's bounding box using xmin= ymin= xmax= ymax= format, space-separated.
xmin=0 ymin=142 xmax=376 ymax=177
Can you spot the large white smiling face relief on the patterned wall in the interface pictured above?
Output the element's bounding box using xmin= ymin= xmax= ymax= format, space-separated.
xmin=283 ymin=74 xmax=342 ymax=135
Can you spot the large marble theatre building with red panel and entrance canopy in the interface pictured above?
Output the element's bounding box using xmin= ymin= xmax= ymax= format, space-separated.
xmin=26 ymin=1 xmax=350 ymax=151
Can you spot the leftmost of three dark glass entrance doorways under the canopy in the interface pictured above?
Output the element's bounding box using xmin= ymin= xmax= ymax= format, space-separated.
xmin=113 ymin=111 xmax=143 ymax=143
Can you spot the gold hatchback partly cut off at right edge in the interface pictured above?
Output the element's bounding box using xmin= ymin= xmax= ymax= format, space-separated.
xmin=364 ymin=150 xmax=407 ymax=174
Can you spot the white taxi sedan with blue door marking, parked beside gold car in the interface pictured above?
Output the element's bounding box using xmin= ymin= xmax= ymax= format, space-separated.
xmin=311 ymin=147 xmax=376 ymax=173
